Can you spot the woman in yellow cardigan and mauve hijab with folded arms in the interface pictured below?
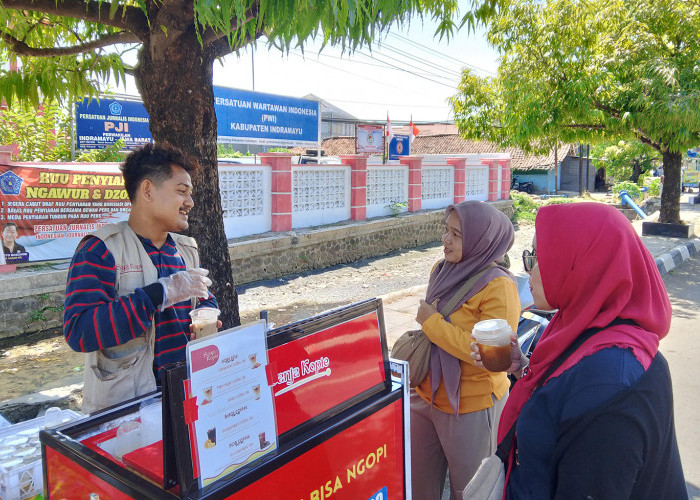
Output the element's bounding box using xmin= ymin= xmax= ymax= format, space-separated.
xmin=411 ymin=201 xmax=520 ymax=500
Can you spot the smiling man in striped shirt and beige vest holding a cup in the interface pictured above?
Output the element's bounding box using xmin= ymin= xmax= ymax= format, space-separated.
xmin=63 ymin=144 xmax=217 ymax=413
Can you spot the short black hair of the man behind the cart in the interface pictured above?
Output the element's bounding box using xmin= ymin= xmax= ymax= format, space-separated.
xmin=120 ymin=144 xmax=196 ymax=203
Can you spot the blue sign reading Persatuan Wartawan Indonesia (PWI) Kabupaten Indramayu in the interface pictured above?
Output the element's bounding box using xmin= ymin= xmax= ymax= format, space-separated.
xmin=214 ymin=87 xmax=321 ymax=147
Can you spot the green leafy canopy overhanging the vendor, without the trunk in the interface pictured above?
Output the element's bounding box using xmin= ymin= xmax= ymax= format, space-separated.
xmin=0 ymin=0 xmax=470 ymax=103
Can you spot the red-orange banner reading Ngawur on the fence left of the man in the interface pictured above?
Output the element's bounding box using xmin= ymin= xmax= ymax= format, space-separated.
xmin=0 ymin=163 xmax=131 ymax=263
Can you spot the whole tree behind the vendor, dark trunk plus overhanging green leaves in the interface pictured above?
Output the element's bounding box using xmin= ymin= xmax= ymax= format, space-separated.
xmin=0 ymin=0 xmax=484 ymax=327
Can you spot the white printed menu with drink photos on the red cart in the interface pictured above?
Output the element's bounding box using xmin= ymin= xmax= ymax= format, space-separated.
xmin=187 ymin=321 xmax=277 ymax=488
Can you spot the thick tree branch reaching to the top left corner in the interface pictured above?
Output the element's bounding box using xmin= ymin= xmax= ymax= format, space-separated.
xmin=2 ymin=0 xmax=148 ymax=38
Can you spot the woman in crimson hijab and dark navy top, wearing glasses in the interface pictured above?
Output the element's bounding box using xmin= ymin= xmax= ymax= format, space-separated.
xmin=486 ymin=203 xmax=687 ymax=499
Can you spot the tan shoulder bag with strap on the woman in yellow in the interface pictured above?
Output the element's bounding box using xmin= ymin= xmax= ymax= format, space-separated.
xmin=391 ymin=264 xmax=495 ymax=387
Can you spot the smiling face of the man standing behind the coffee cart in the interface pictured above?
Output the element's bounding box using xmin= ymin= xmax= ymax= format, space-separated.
xmin=148 ymin=165 xmax=194 ymax=232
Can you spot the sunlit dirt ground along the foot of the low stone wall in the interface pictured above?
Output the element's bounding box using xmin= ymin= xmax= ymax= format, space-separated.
xmin=0 ymin=220 xmax=534 ymax=401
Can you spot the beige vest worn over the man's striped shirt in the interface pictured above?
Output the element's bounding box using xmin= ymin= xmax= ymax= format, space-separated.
xmin=82 ymin=222 xmax=199 ymax=413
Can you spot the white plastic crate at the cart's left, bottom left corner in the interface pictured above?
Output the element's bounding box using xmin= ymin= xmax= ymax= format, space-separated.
xmin=0 ymin=410 xmax=80 ymax=500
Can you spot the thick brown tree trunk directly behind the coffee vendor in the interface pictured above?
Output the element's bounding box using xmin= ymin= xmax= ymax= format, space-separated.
xmin=135 ymin=30 xmax=240 ymax=328
